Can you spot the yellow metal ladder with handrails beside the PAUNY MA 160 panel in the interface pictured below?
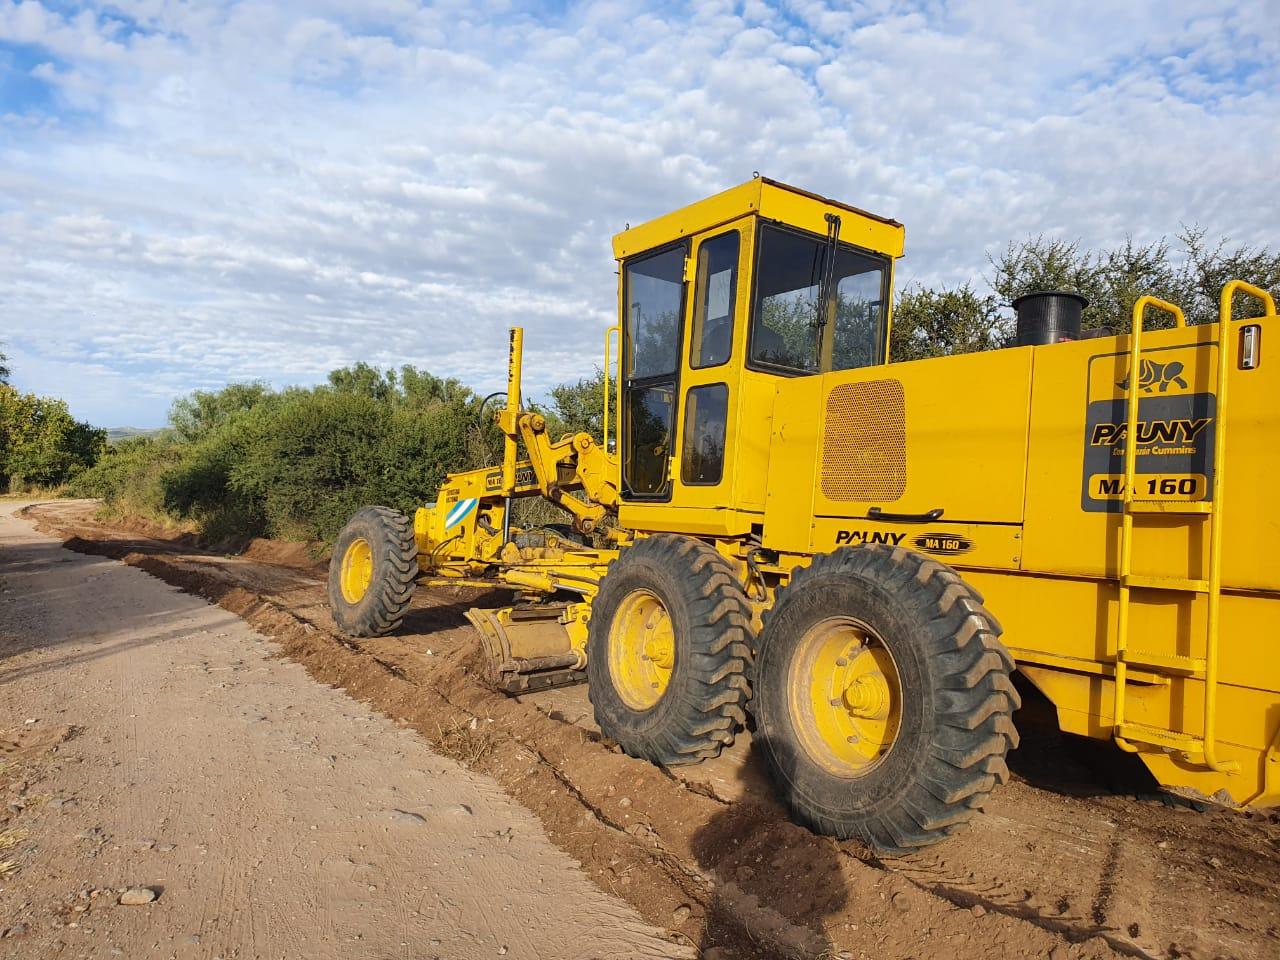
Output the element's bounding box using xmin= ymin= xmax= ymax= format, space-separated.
xmin=1112 ymin=280 xmax=1276 ymax=773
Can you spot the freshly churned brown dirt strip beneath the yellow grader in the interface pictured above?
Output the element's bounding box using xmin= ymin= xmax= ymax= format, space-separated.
xmin=0 ymin=503 xmax=1280 ymax=960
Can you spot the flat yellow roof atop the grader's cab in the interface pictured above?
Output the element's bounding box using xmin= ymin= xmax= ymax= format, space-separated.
xmin=613 ymin=177 xmax=905 ymax=260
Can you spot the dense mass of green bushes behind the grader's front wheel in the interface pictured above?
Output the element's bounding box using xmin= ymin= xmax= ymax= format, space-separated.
xmin=73 ymin=365 xmax=502 ymax=541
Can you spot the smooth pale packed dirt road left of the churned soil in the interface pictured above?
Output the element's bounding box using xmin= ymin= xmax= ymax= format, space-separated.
xmin=0 ymin=502 xmax=692 ymax=960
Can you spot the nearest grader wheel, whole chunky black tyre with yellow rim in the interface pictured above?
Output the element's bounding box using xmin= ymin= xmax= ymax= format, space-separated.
xmin=753 ymin=545 xmax=1020 ymax=854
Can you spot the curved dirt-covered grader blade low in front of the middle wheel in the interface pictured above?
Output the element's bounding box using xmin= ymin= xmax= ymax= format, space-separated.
xmin=467 ymin=603 xmax=586 ymax=694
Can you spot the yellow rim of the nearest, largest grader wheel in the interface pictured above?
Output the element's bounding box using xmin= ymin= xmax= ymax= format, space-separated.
xmin=787 ymin=617 xmax=902 ymax=778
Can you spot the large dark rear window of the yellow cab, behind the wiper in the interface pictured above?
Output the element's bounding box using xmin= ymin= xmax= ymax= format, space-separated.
xmin=750 ymin=224 xmax=888 ymax=375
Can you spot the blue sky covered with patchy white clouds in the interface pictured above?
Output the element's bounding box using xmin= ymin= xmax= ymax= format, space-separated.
xmin=0 ymin=0 xmax=1280 ymax=428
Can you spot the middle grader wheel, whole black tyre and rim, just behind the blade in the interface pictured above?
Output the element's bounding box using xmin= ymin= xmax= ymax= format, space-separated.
xmin=586 ymin=534 xmax=751 ymax=767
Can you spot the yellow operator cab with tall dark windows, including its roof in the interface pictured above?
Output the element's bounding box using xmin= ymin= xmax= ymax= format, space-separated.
xmin=605 ymin=178 xmax=902 ymax=536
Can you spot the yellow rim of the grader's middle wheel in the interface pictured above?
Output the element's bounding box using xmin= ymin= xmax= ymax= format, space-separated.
xmin=609 ymin=590 xmax=676 ymax=710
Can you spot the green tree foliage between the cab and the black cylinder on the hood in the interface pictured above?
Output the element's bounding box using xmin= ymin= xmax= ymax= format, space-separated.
xmin=890 ymin=284 xmax=1012 ymax=361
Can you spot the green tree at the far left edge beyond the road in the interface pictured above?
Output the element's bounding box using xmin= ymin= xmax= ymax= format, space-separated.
xmin=0 ymin=385 xmax=106 ymax=489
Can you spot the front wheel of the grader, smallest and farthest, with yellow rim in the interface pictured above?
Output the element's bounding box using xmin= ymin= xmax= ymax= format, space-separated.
xmin=329 ymin=507 xmax=417 ymax=636
